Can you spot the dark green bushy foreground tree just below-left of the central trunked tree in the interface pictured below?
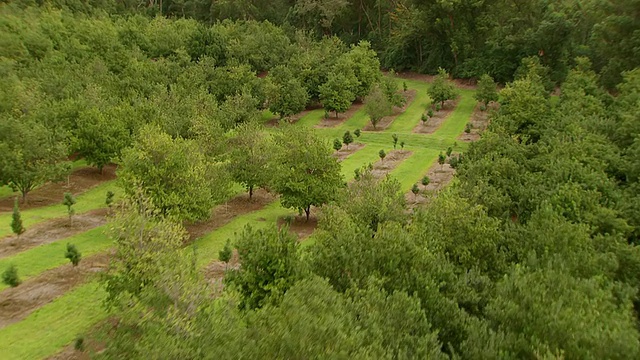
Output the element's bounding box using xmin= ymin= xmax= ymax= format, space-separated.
xmin=225 ymin=225 xmax=301 ymax=310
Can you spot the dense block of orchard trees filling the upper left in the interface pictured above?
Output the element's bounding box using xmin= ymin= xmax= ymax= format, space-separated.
xmin=0 ymin=4 xmax=398 ymax=202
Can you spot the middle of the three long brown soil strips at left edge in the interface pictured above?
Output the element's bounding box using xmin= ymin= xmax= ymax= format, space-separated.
xmin=0 ymin=209 xmax=108 ymax=259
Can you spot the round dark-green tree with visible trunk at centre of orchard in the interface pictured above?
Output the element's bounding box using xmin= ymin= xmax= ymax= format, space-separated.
xmin=271 ymin=126 xmax=343 ymax=220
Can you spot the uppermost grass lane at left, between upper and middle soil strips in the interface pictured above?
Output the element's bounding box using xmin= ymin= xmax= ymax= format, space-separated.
xmin=0 ymin=180 xmax=122 ymax=238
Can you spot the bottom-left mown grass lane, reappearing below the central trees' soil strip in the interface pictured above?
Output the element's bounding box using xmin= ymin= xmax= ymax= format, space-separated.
xmin=0 ymin=201 xmax=298 ymax=359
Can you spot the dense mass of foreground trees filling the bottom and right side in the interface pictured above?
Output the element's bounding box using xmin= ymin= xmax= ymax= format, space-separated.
xmin=100 ymin=58 xmax=640 ymax=359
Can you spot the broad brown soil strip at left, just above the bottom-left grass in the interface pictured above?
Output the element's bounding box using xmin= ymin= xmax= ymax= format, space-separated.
xmin=0 ymin=253 xmax=111 ymax=328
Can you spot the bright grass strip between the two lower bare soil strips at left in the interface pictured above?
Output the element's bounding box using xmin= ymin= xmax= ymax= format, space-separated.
xmin=0 ymin=226 xmax=113 ymax=294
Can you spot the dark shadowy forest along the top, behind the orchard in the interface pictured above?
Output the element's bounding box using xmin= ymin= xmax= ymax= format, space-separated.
xmin=18 ymin=0 xmax=640 ymax=89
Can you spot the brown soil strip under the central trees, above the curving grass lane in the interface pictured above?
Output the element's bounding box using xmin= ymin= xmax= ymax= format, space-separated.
xmin=186 ymin=189 xmax=275 ymax=241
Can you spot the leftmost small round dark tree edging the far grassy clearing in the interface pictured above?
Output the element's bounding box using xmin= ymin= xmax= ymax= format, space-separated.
xmin=266 ymin=65 xmax=309 ymax=117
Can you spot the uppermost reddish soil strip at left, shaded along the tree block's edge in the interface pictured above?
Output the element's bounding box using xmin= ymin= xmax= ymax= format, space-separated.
xmin=0 ymin=165 xmax=116 ymax=212
